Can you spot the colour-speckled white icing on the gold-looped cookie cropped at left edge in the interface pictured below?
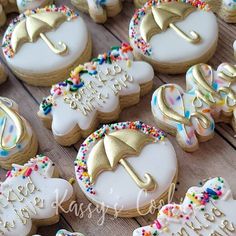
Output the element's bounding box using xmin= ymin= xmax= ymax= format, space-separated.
xmin=0 ymin=97 xmax=33 ymax=160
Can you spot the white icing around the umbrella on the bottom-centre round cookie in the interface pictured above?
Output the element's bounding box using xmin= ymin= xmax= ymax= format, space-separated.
xmin=75 ymin=122 xmax=177 ymax=214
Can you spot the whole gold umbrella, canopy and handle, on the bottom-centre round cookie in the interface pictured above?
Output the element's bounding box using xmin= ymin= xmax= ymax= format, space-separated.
xmin=87 ymin=129 xmax=157 ymax=191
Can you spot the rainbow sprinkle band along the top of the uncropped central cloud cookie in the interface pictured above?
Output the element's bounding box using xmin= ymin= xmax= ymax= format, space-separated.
xmin=40 ymin=43 xmax=133 ymax=115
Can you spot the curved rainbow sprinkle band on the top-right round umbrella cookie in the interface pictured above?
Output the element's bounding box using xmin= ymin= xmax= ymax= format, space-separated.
xmin=129 ymin=0 xmax=210 ymax=56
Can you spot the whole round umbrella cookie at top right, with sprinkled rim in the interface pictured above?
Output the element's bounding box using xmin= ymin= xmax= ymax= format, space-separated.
xmin=129 ymin=0 xmax=218 ymax=74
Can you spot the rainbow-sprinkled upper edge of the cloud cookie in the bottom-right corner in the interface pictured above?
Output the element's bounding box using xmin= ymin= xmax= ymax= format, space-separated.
xmin=133 ymin=177 xmax=232 ymax=236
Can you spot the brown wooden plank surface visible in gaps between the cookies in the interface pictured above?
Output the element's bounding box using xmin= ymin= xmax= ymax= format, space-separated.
xmin=0 ymin=0 xmax=236 ymax=236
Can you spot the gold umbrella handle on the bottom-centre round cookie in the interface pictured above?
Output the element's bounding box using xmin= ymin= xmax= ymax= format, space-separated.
xmin=119 ymin=159 xmax=157 ymax=191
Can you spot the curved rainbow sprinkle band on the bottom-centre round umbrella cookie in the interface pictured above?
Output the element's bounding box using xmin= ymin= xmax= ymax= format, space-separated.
xmin=74 ymin=121 xmax=166 ymax=195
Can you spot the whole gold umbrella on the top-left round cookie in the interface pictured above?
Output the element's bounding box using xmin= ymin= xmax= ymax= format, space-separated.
xmin=11 ymin=12 xmax=67 ymax=54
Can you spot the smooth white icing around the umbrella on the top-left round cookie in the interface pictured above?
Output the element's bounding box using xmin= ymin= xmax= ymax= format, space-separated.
xmin=3 ymin=6 xmax=88 ymax=74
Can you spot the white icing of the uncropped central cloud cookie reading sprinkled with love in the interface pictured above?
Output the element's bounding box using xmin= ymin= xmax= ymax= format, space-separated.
xmin=39 ymin=45 xmax=154 ymax=139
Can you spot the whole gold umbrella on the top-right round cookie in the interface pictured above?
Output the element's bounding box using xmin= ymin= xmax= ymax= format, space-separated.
xmin=140 ymin=2 xmax=201 ymax=44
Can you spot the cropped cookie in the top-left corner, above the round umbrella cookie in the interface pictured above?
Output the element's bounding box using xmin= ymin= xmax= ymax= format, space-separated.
xmin=0 ymin=0 xmax=53 ymax=26
